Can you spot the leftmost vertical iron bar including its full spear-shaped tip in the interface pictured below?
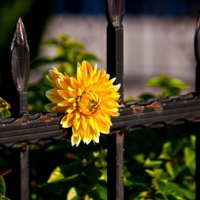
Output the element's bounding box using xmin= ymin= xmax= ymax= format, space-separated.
xmin=11 ymin=18 xmax=30 ymax=200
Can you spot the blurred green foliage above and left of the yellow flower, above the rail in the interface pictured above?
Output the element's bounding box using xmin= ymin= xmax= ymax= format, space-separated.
xmin=28 ymin=35 xmax=99 ymax=113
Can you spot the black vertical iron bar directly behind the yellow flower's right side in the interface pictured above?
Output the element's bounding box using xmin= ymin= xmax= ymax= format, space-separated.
xmin=105 ymin=0 xmax=125 ymax=200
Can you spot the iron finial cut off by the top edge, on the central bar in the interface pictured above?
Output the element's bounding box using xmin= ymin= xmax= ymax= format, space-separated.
xmin=106 ymin=0 xmax=125 ymax=26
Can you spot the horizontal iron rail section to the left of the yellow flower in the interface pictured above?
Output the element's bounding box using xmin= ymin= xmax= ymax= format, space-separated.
xmin=0 ymin=113 xmax=66 ymax=148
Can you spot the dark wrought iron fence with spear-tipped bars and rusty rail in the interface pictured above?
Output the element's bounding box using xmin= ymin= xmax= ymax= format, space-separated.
xmin=0 ymin=0 xmax=200 ymax=200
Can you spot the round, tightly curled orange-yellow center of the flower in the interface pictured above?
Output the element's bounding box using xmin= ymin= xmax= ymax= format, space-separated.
xmin=78 ymin=92 xmax=101 ymax=115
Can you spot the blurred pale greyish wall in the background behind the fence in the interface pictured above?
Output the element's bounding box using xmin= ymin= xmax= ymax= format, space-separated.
xmin=41 ymin=15 xmax=196 ymax=97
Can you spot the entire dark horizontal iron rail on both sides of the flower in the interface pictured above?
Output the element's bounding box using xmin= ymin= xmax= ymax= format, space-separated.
xmin=0 ymin=93 xmax=200 ymax=147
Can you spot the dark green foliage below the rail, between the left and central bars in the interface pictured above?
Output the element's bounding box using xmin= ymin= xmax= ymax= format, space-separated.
xmin=31 ymin=141 xmax=107 ymax=200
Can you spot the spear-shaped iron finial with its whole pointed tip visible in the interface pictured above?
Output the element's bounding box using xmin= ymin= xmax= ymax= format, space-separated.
xmin=11 ymin=18 xmax=30 ymax=91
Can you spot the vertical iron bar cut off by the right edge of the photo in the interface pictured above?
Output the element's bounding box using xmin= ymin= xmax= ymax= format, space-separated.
xmin=194 ymin=13 xmax=200 ymax=200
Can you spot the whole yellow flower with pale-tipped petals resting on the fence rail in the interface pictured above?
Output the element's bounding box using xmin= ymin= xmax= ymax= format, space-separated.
xmin=46 ymin=61 xmax=120 ymax=146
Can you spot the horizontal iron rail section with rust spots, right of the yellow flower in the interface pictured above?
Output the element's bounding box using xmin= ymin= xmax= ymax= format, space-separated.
xmin=111 ymin=93 xmax=200 ymax=132
